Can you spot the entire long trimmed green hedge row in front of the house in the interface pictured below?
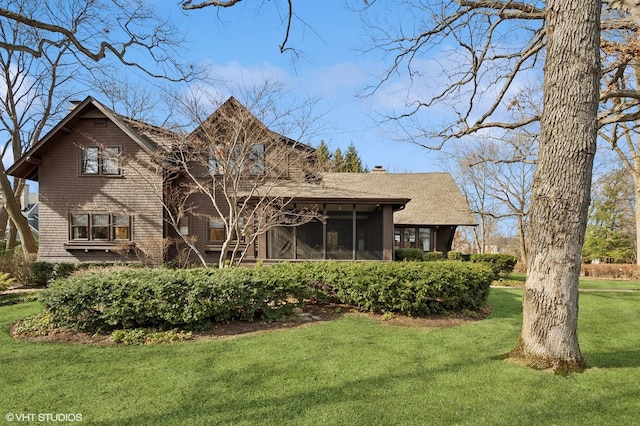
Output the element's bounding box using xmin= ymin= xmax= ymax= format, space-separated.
xmin=42 ymin=261 xmax=493 ymax=331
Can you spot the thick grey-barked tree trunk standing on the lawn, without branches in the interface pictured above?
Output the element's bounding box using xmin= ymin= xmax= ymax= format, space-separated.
xmin=510 ymin=0 xmax=600 ymax=372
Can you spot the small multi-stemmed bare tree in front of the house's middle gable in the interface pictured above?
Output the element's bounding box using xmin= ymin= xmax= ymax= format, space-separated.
xmin=123 ymin=85 xmax=323 ymax=267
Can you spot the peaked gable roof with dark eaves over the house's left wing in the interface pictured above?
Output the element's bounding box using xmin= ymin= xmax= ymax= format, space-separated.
xmin=7 ymin=96 xmax=172 ymax=181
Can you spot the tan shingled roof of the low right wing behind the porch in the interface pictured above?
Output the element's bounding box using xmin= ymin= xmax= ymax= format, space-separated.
xmin=322 ymin=173 xmax=477 ymax=225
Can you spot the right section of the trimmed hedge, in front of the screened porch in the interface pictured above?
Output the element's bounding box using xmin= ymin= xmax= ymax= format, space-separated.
xmin=271 ymin=261 xmax=494 ymax=316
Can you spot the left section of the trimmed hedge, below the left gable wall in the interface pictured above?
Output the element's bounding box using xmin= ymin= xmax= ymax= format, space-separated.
xmin=41 ymin=268 xmax=308 ymax=331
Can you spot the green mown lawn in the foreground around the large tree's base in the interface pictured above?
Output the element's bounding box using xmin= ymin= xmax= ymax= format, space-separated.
xmin=0 ymin=289 xmax=640 ymax=425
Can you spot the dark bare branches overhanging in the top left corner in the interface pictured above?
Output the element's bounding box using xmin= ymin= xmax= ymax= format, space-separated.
xmin=0 ymin=0 xmax=195 ymax=81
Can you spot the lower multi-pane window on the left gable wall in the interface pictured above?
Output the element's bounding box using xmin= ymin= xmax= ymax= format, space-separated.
xmin=70 ymin=213 xmax=131 ymax=241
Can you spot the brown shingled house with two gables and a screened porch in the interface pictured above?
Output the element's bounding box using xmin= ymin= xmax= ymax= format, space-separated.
xmin=7 ymin=97 xmax=475 ymax=264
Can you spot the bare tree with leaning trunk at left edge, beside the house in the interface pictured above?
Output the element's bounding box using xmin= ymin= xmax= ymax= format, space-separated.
xmin=0 ymin=1 xmax=79 ymax=254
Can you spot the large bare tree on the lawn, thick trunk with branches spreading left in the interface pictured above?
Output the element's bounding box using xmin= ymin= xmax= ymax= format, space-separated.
xmin=176 ymin=0 xmax=601 ymax=371
